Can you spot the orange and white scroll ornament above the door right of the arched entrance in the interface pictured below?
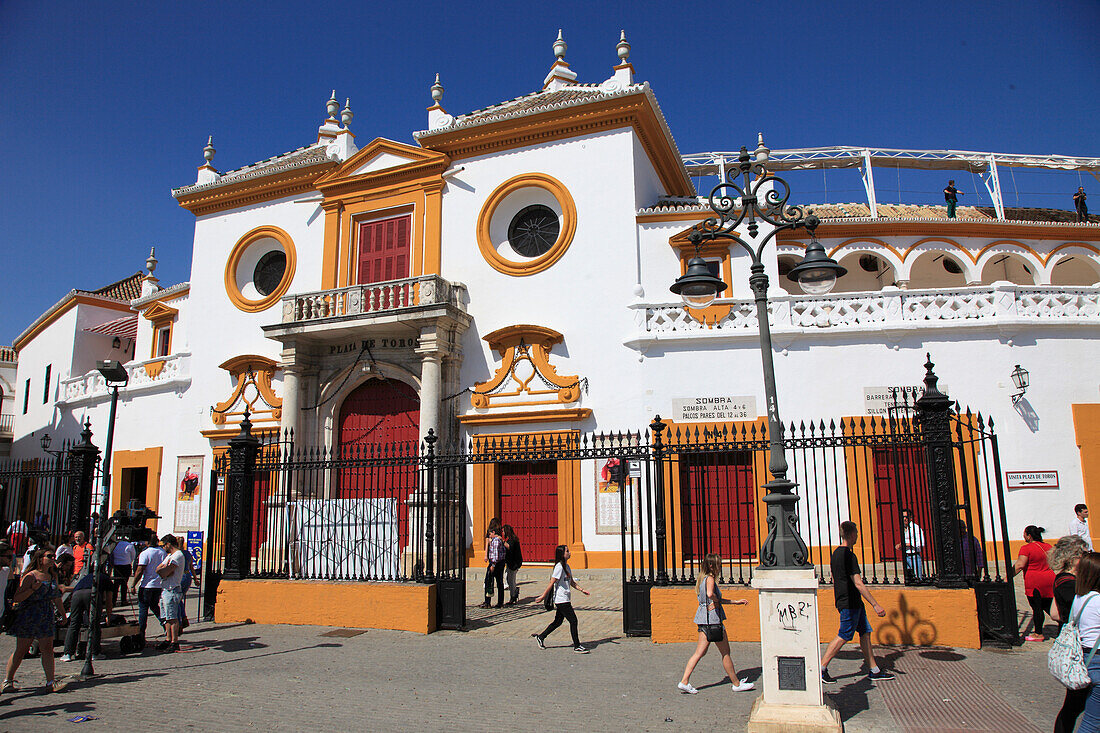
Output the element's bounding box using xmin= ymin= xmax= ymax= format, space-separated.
xmin=471 ymin=326 xmax=587 ymax=409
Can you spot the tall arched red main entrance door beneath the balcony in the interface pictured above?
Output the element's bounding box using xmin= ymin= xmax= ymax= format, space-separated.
xmin=337 ymin=380 xmax=420 ymax=548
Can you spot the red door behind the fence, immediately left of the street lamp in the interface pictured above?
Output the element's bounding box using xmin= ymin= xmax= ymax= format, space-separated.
xmin=680 ymin=451 xmax=757 ymax=560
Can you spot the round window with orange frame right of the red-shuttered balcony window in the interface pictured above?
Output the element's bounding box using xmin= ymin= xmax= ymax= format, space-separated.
xmin=477 ymin=173 xmax=576 ymax=277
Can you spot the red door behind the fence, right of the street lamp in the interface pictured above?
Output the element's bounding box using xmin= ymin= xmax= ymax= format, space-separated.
xmin=872 ymin=446 xmax=931 ymax=560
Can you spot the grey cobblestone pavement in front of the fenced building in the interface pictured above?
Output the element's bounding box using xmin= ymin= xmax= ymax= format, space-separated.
xmin=0 ymin=589 xmax=1063 ymax=733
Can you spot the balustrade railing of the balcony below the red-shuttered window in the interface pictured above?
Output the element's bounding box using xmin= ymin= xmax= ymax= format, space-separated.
xmin=283 ymin=275 xmax=465 ymax=324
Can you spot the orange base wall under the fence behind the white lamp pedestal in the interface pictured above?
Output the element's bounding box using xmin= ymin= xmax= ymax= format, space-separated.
xmin=649 ymin=587 xmax=981 ymax=649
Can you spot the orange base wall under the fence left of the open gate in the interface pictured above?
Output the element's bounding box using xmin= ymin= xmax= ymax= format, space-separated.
xmin=215 ymin=580 xmax=437 ymax=634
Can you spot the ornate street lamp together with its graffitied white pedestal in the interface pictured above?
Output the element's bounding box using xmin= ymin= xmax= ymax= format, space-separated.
xmin=671 ymin=135 xmax=846 ymax=732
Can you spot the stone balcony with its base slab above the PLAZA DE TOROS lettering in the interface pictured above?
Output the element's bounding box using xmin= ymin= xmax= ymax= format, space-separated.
xmin=264 ymin=275 xmax=470 ymax=340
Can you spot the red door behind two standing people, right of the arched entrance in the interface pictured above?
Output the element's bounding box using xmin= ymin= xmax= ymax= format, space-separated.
xmin=499 ymin=461 xmax=559 ymax=562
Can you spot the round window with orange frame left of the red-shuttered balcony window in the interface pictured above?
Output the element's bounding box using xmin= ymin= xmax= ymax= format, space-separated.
xmin=226 ymin=227 xmax=296 ymax=313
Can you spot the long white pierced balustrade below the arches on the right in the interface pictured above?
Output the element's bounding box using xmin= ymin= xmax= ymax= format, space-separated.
xmin=625 ymin=282 xmax=1100 ymax=349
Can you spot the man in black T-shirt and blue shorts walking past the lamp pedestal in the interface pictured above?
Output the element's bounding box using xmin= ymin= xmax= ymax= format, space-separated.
xmin=822 ymin=522 xmax=894 ymax=685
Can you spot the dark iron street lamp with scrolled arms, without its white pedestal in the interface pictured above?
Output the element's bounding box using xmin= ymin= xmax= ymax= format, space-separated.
xmin=670 ymin=135 xmax=847 ymax=568
